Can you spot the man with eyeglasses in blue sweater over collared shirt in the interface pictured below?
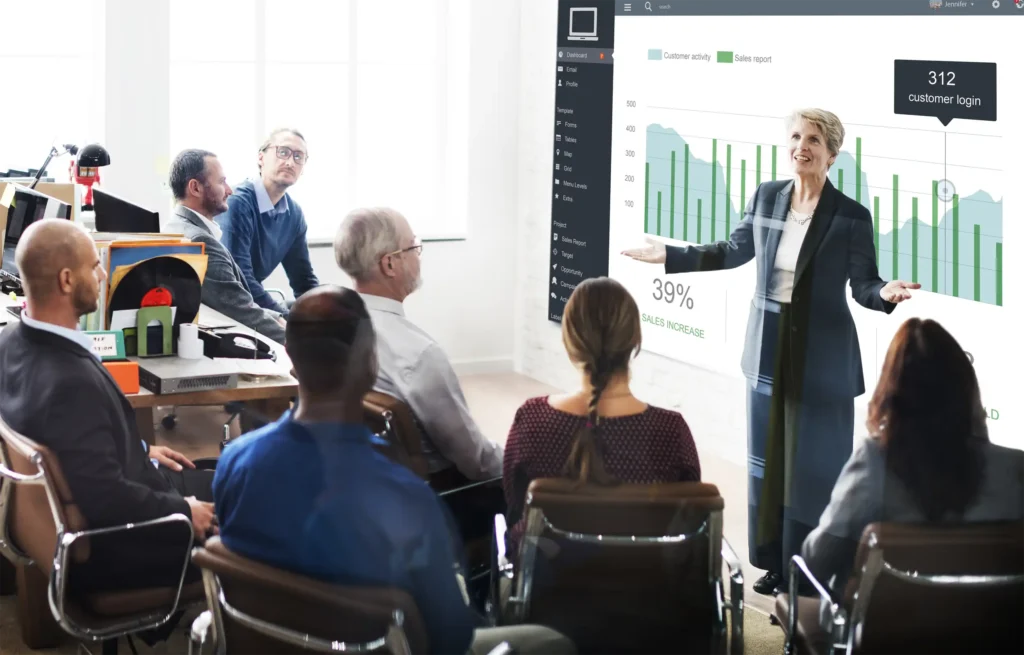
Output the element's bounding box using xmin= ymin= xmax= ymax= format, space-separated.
xmin=216 ymin=128 xmax=319 ymax=316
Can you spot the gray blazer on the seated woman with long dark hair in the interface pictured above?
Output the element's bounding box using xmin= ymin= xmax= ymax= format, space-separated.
xmin=802 ymin=438 xmax=1024 ymax=590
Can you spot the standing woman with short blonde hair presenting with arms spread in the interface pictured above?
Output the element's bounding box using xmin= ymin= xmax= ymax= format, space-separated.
xmin=623 ymin=108 xmax=921 ymax=594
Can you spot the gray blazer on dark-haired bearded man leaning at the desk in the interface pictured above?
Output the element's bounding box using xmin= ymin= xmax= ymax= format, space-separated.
xmin=164 ymin=205 xmax=285 ymax=344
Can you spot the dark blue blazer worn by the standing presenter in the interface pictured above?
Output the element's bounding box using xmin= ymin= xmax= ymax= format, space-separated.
xmin=665 ymin=180 xmax=896 ymax=400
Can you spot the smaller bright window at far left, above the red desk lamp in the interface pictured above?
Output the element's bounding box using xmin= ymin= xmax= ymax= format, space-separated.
xmin=0 ymin=0 xmax=105 ymax=181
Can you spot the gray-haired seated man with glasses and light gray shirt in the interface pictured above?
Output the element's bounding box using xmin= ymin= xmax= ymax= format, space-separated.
xmin=334 ymin=208 xmax=502 ymax=480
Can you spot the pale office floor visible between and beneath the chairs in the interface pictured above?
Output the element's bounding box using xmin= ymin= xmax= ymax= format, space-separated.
xmin=0 ymin=374 xmax=782 ymax=655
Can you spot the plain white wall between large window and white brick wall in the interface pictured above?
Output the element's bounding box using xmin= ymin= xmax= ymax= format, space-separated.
xmin=266 ymin=0 xmax=520 ymax=373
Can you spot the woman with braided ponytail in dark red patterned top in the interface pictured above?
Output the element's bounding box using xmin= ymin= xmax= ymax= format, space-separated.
xmin=503 ymin=277 xmax=700 ymax=557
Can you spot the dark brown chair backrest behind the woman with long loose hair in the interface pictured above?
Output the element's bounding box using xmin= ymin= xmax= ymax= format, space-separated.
xmin=846 ymin=522 xmax=1024 ymax=653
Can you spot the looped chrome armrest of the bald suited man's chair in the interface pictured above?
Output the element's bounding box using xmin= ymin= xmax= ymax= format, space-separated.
xmin=50 ymin=514 xmax=196 ymax=639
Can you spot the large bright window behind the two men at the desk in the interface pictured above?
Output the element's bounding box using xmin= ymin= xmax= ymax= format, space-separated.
xmin=171 ymin=0 xmax=469 ymax=241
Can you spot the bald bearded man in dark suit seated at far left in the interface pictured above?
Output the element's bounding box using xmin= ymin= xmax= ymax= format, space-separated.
xmin=0 ymin=219 xmax=215 ymax=593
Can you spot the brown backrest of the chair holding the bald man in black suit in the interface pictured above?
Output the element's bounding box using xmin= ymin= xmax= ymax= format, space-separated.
xmin=0 ymin=419 xmax=89 ymax=576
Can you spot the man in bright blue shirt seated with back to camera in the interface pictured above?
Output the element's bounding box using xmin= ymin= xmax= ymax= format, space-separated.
xmin=214 ymin=286 xmax=571 ymax=654
